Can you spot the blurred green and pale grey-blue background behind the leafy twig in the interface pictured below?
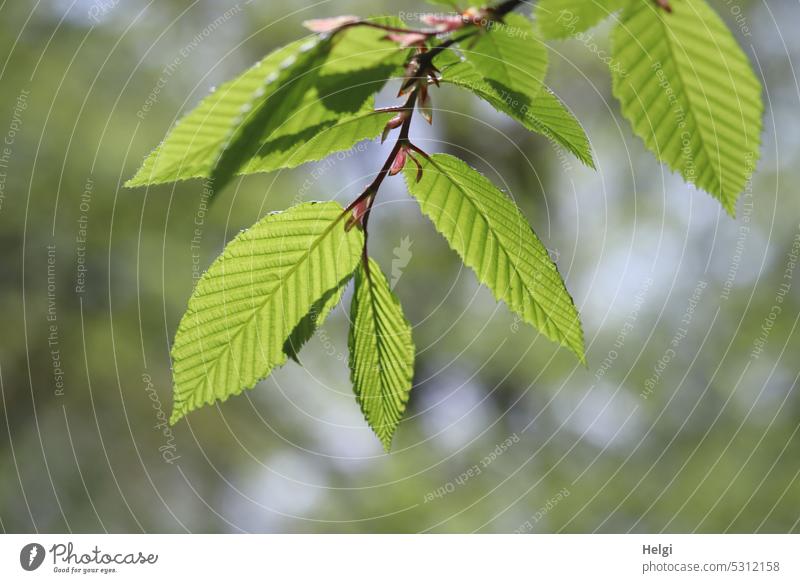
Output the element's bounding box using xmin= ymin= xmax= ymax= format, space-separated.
xmin=0 ymin=0 xmax=800 ymax=532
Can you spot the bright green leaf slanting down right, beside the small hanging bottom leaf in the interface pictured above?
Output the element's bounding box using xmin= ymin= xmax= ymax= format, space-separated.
xmin=405 ymin=154 xmax=585 ymax=362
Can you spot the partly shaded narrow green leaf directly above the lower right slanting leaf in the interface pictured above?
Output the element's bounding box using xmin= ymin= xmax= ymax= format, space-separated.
xmin=437 ymin=52 xmax=594 ymax=168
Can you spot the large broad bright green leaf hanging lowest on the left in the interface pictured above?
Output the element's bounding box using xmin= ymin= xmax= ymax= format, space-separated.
xmin=175 ymin=202 xmax=363 ymax=423
